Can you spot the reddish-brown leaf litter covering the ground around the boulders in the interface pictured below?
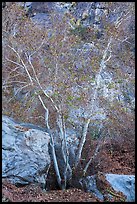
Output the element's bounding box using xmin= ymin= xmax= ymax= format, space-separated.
xmin=2 ymin=136 xmax=135 ymax=202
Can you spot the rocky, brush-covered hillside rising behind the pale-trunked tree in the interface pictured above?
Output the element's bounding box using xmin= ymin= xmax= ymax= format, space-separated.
xmin=2 ymin=2 xmax=135 ymax=139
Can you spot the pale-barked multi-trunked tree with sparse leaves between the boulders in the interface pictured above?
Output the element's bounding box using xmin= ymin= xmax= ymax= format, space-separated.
xmin=2 ymin=1 xmax=135 ymax=189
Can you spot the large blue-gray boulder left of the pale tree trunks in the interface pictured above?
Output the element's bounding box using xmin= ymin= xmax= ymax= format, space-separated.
xmin=2 ymin=116 xmax=50 ymax=185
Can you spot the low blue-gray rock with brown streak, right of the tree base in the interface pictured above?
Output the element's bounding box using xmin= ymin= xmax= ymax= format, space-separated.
xmin=80 ymin=173 xmax=135 ymax=202
